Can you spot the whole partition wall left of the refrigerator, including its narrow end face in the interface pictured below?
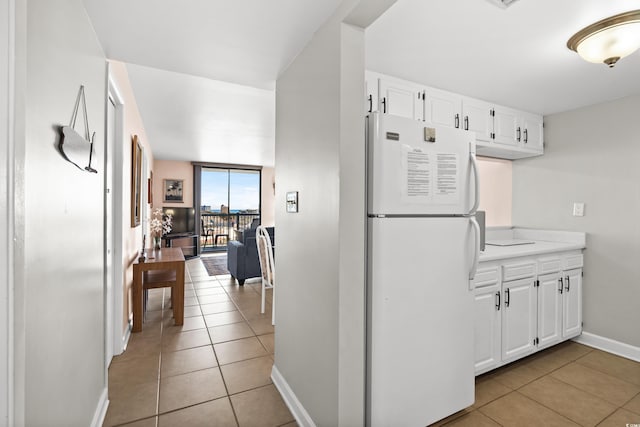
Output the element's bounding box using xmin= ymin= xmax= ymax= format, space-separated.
xmin=274 ymin=0 xmax=393 ymax=426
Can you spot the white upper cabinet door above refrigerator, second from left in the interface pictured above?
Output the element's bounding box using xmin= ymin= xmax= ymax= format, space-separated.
xmin=378 ymin=79 xmax=424 ymax=120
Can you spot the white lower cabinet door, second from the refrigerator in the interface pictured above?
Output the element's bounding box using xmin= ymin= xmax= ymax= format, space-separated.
xmin=502 ymin=277 xmax=537 ymax=362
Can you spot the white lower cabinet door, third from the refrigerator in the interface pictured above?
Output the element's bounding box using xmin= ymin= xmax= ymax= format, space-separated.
xmin=537 ymin=272 xmax=564 ymax=348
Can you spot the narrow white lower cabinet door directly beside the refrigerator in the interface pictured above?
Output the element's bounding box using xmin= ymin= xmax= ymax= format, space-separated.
xmin=474 ymin=283 xmax=502 ymax=375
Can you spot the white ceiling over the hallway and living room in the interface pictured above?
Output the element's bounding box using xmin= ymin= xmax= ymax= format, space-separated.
xmin=84 ymin=0 xmax=341 ymax=166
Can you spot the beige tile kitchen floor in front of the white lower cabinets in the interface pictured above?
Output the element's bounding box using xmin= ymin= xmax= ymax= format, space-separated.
xmin=435 ymin=341 xmax=640 ymax=427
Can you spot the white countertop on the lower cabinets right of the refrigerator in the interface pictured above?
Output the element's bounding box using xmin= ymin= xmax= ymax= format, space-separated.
xmin=480 ymin=227 xmax=586 ymax=262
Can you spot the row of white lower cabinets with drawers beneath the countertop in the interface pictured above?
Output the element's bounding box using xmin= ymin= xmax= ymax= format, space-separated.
xmin=474 ymin=251 xmax=582 ymax=375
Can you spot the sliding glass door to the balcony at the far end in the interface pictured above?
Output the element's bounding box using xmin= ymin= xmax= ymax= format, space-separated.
xmin=199 ymin=167 xmax=260 ymax=252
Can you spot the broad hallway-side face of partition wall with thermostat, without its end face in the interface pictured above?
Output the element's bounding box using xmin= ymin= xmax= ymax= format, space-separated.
xmin=275 ymin=13 xmax=340 ymax=426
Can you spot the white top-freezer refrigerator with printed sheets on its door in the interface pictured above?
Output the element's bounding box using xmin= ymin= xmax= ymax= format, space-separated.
xmin=367 ymin=113 xmax=480 ymax=427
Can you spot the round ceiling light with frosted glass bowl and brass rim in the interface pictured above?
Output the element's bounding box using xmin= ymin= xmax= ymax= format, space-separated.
xmin=567 ymin=10 xmax=640 ymax=68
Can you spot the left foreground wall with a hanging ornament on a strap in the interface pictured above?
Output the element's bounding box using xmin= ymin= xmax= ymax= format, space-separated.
xmin=15 ymin=0 xmax=106 ymax=426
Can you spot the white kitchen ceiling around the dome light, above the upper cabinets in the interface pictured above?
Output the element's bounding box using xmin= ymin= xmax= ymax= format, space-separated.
xmin=366 ymin=0 xmax=640 ymax=114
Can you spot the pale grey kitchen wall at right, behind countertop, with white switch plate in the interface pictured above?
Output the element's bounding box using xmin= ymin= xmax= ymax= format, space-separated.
xmin=513 ymin=95 xmax=640 ymax=347
